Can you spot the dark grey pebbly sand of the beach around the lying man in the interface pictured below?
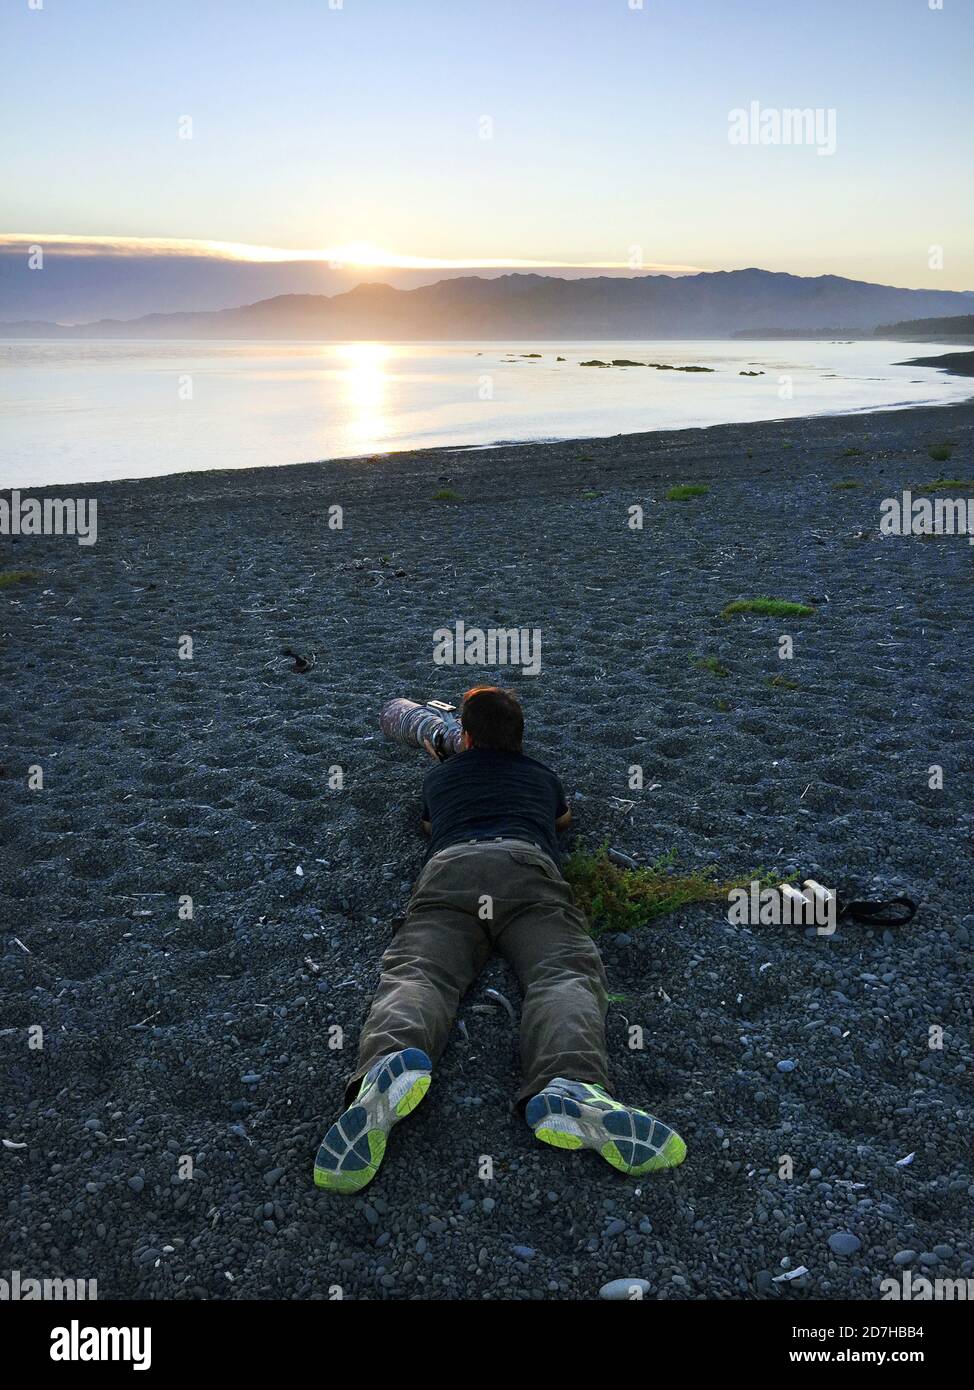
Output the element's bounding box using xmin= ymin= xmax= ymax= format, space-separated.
xmin=0 ymin=404 xmax=974 ymax=1300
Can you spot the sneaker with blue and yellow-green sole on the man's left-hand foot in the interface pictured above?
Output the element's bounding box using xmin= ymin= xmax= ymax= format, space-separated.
xmin=314 ymin=1047 xmax=432 ymax=1193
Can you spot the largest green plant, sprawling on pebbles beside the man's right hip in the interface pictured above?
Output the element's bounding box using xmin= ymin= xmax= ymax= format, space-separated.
xmin=564 ymin=845 xmax=763 ymax=935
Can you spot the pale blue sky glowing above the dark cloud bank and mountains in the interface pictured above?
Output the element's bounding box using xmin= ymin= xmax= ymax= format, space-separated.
xmin=0 ymin=0 xmax=974 ymax=289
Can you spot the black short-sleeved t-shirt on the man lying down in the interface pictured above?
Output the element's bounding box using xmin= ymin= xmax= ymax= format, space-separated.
xmin=422 ymin=748 xmax=568 ymax=863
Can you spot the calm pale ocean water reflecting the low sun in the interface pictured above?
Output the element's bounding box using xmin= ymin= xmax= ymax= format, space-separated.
xmin=0 ymin=339 xmax=974 ymax=488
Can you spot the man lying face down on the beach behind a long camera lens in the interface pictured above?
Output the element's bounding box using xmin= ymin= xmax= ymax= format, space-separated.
xmin=314 ymin=685 xmax=686 ymax=1193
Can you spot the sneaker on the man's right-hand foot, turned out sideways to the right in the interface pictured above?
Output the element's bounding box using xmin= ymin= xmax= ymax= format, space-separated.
xmin=524 ymin=1076 xmax=686 ymax=1177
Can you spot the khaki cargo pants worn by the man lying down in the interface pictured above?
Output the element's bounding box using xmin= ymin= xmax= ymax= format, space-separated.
xmin=346 ymin=840 xmax=609 ymax=1104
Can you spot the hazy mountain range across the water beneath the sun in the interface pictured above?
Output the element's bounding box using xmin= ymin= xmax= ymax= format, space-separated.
xmin=0 ymin=270 xmax=974 ymax=342
